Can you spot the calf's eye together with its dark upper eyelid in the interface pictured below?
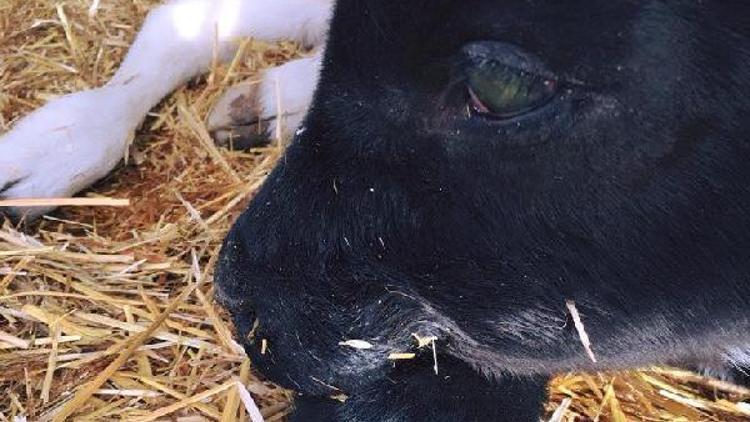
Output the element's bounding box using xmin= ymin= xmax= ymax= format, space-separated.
xmin=463 ymin=41 xmax=558 ymax=119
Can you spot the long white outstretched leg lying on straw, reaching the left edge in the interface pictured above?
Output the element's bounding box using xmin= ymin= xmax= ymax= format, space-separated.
xmin=0 ymin=0 xmax=332 ymax=216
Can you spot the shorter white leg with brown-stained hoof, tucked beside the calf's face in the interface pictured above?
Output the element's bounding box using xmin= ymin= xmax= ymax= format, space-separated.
xmin=208 ymin=50 xmax=322 ymax=146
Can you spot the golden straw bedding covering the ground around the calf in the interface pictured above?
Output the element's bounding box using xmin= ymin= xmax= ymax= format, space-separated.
xmin=0 ymin=0 xmax=750 ymax=421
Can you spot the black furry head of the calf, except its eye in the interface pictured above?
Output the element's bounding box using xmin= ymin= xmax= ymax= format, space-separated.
xmin=217 ymin=0 xmax=750 ymax=421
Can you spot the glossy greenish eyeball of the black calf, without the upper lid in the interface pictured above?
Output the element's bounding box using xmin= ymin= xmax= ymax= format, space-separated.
xmin=467 ymin=60 xmax=558 ymax=118
